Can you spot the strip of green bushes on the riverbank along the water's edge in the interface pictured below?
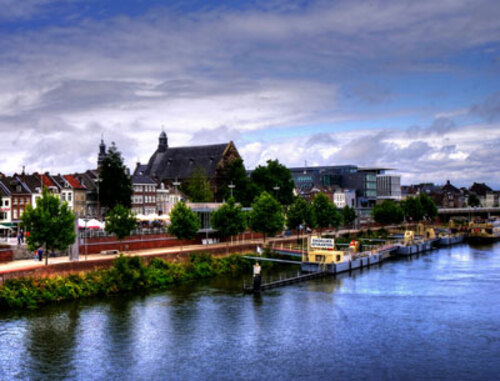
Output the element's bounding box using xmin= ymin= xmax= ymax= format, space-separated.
xmin=0 ymin=254 xmax=258 ymax=310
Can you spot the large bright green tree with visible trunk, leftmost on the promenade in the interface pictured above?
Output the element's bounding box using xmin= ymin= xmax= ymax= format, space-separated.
xmin=21 ymin=188 xmax=76 ymax=265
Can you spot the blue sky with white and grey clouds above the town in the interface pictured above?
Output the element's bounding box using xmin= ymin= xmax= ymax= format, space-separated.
xmin=0 ymin=0 xmax=500 ymax=189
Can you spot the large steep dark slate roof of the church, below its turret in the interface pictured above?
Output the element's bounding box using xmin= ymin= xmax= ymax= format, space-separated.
xmin=145 ymin=143 xmax=229 ymax=179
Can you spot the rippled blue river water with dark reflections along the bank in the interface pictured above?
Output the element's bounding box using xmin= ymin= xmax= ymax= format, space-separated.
xmin=0 ymin=244 xmax=500 ymax=380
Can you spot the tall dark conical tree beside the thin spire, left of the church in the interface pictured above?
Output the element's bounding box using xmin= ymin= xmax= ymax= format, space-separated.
xmin=98 ymin=143 xmax=133 ymax=209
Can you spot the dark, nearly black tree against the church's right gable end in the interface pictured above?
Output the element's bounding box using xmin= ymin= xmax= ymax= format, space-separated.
xmin=216 ymin=158 xmax=258 ymax=206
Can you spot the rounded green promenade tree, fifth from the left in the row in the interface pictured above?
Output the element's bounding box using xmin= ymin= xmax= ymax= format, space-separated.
xmin=250 ymin=192 xmax=285 ymax=242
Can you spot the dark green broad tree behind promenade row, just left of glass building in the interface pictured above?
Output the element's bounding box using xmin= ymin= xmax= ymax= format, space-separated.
xmin=251 ymin=160 xmax=295 ymax=205
